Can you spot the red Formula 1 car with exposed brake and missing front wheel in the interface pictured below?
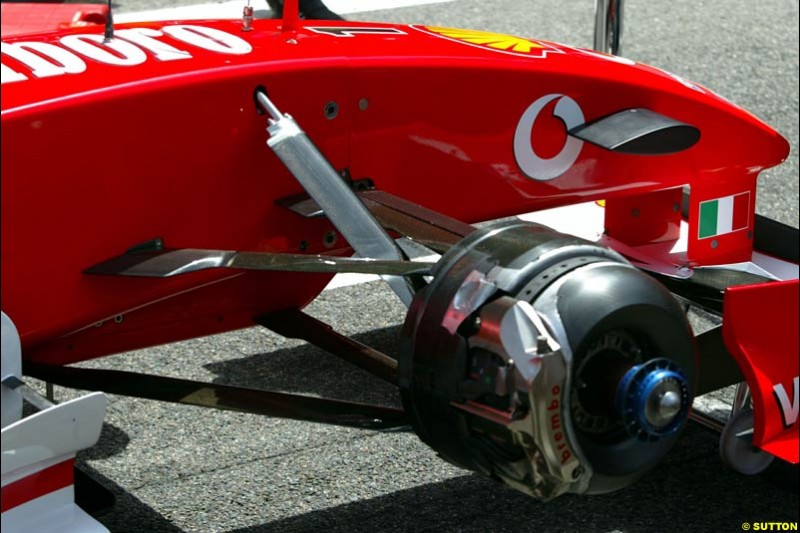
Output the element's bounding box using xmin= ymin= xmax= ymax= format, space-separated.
xmin=2 ymin=1 xmax=798 ymax=531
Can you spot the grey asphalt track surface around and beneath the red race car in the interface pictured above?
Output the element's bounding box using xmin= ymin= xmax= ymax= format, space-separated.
xmin=34 ymin=0 xmax=800 ymax=533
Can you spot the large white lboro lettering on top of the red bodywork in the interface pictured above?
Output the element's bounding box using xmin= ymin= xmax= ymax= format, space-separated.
xmin=0 ymin=24 xmax=253 ymax=84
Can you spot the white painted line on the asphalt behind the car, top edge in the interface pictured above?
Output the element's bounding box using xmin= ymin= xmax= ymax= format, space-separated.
xmin=114 ymin=0 xmax=455 ymax=23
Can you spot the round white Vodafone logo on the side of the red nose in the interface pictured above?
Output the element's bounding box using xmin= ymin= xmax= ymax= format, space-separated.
xmin=514 ymin=94 xmax=585 ymax=181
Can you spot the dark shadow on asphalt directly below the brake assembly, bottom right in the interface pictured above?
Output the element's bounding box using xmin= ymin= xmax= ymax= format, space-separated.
xmin=230 ymin=424 xmax=798 ymax=533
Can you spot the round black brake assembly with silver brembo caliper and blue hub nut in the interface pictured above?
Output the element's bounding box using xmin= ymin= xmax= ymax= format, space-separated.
xmin=399 ymin=220 xmax=696 ymax=500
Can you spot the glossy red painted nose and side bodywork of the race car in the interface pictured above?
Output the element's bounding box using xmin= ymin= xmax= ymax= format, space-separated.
xmin=0 ymin=20 xmax=788 ymax=372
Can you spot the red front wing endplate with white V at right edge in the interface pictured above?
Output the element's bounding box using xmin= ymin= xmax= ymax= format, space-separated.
xmin=722 ymin=280 xmax=800 ymax=463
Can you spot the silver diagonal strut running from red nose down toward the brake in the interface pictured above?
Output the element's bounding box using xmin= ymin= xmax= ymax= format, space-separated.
xmin=256 ymin=91 xmax=414 ymax=307
